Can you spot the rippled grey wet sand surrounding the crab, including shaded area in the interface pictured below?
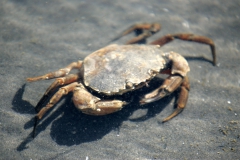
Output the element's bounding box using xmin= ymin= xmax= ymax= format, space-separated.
xmin=0 ymin=0 xmax=240 ymax=160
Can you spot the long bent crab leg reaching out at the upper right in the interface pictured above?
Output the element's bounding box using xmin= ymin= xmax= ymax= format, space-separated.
xmin=150 ymin=33 xmax=216 ymax=66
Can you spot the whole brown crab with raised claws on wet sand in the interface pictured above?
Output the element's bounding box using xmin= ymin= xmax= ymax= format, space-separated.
xmin=27 ymin=23 xmax=216 ymax=134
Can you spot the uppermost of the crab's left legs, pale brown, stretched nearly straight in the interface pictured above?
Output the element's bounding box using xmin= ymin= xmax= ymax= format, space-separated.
xmin=27 ymin=61 xmax=82 ymax=82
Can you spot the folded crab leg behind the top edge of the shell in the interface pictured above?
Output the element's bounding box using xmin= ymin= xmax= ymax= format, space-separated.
xmin=112 ymin=23 xmax=161 ymax=44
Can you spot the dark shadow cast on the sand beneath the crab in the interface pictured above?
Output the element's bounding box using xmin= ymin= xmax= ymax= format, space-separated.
xmin=12 ymin=80 xmax=177 ymax=151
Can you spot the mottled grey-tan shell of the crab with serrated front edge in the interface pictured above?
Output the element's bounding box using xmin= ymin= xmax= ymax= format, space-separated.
xmin=82 ymin=44 xmax=166 ymax=95
